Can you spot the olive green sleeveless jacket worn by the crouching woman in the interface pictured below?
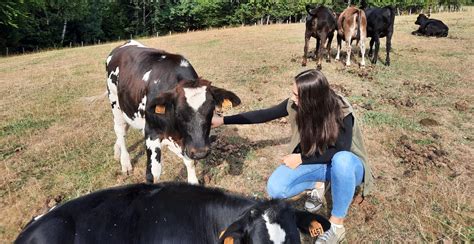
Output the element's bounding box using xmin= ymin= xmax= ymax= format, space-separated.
xmin=286 ymin=95 xmax=374 ymax=196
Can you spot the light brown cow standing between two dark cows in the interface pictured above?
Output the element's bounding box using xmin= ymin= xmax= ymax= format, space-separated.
xmin=336 ymin=6 xmax=367 ymax=66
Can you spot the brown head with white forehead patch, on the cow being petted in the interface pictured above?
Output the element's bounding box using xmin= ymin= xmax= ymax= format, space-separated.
xmin=146 ymin=79 xmax=240 ymax=159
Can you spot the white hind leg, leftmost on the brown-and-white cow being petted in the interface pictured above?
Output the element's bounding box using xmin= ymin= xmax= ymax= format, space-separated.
xmin=112 ymin=109 xmax=132 ymax=174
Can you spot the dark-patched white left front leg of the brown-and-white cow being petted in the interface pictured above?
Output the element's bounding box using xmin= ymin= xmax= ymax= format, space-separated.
xmin=145 ymin=133 xmax=162 ymax=183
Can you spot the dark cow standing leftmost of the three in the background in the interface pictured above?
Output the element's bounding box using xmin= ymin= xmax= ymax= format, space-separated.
xmin=302 ymin=5 xmax=337 ymax=69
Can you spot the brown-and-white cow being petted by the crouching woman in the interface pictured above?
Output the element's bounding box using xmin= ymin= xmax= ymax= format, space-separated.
xmin=106 ymin=40 xmax=240 ymax=184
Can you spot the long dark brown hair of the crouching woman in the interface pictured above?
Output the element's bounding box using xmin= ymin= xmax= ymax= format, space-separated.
xmin=295 ymin=69 xmax=342 ymax=156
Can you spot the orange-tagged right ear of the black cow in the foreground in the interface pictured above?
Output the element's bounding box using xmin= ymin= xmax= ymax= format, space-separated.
xmin=295 ymin=210 xmax=331 ymax=237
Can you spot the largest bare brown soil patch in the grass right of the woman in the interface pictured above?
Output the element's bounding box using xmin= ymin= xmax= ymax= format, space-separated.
xmin=393 ymin=135 xmax=452 ymax=173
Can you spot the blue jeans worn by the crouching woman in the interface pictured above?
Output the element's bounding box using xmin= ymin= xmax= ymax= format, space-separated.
xmin=267 ymin=151 xmax=364 ymax=218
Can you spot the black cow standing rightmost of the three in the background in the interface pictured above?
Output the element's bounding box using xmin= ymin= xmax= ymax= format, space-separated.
xmin=364 ymin=6 xmax=395 ymax=66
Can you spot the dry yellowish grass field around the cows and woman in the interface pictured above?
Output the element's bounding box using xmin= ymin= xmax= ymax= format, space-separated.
xmin=0 ymin=8 xmax=474 ymax=243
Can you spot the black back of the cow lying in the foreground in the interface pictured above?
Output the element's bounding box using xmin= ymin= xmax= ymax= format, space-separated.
xmin=15 ymin=183 xmax=254 ymax=244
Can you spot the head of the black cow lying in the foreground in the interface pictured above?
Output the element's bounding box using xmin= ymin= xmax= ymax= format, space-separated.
xmin=219 ymin=200 xmax=331 ymax=244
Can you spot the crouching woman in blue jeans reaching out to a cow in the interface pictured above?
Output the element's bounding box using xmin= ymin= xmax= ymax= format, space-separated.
xmin=212 ymin=69 xmax=373 ymax=243
